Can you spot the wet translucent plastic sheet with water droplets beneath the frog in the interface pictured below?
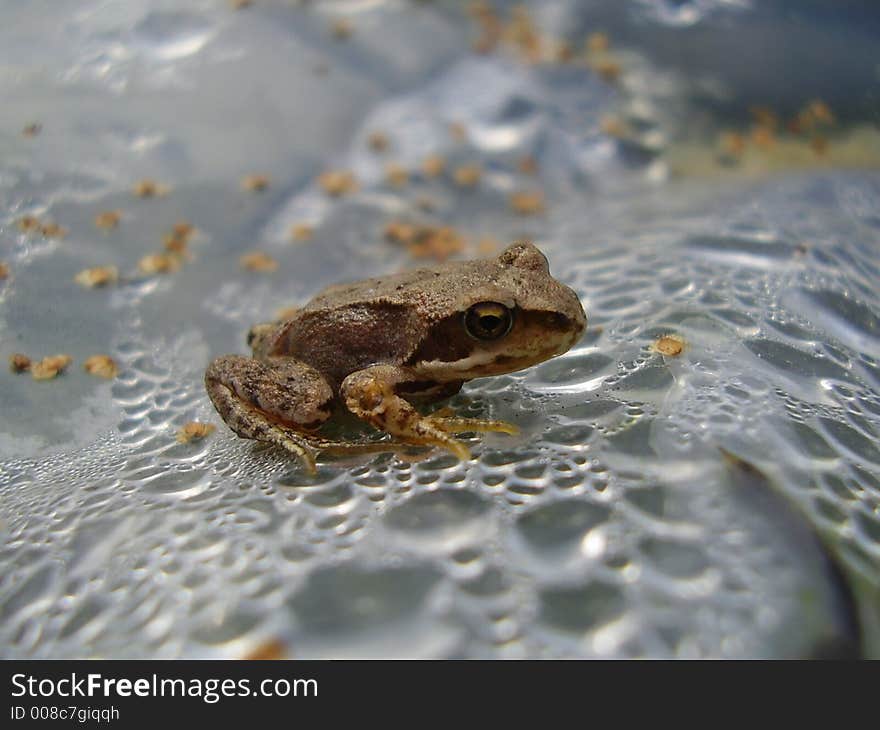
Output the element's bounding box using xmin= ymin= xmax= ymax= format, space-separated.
xmin=0 ymin=2 xmax=880 ymax=657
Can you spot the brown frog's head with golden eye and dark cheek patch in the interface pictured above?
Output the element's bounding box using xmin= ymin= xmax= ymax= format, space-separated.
xmin=409 ymin=242 xmax=587 ymax=382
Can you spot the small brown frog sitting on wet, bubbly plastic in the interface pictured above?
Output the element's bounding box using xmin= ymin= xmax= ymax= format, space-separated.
xmin=205 ymin=241 xmax=587 ymax=473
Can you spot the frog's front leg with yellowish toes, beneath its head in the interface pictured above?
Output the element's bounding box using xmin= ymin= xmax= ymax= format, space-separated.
xmin=340 ymin=365 xmax=512 ymax=461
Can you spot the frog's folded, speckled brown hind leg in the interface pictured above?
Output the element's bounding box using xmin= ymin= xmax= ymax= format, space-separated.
xmin=205 ymin=355 xmax=333 ymax=472
